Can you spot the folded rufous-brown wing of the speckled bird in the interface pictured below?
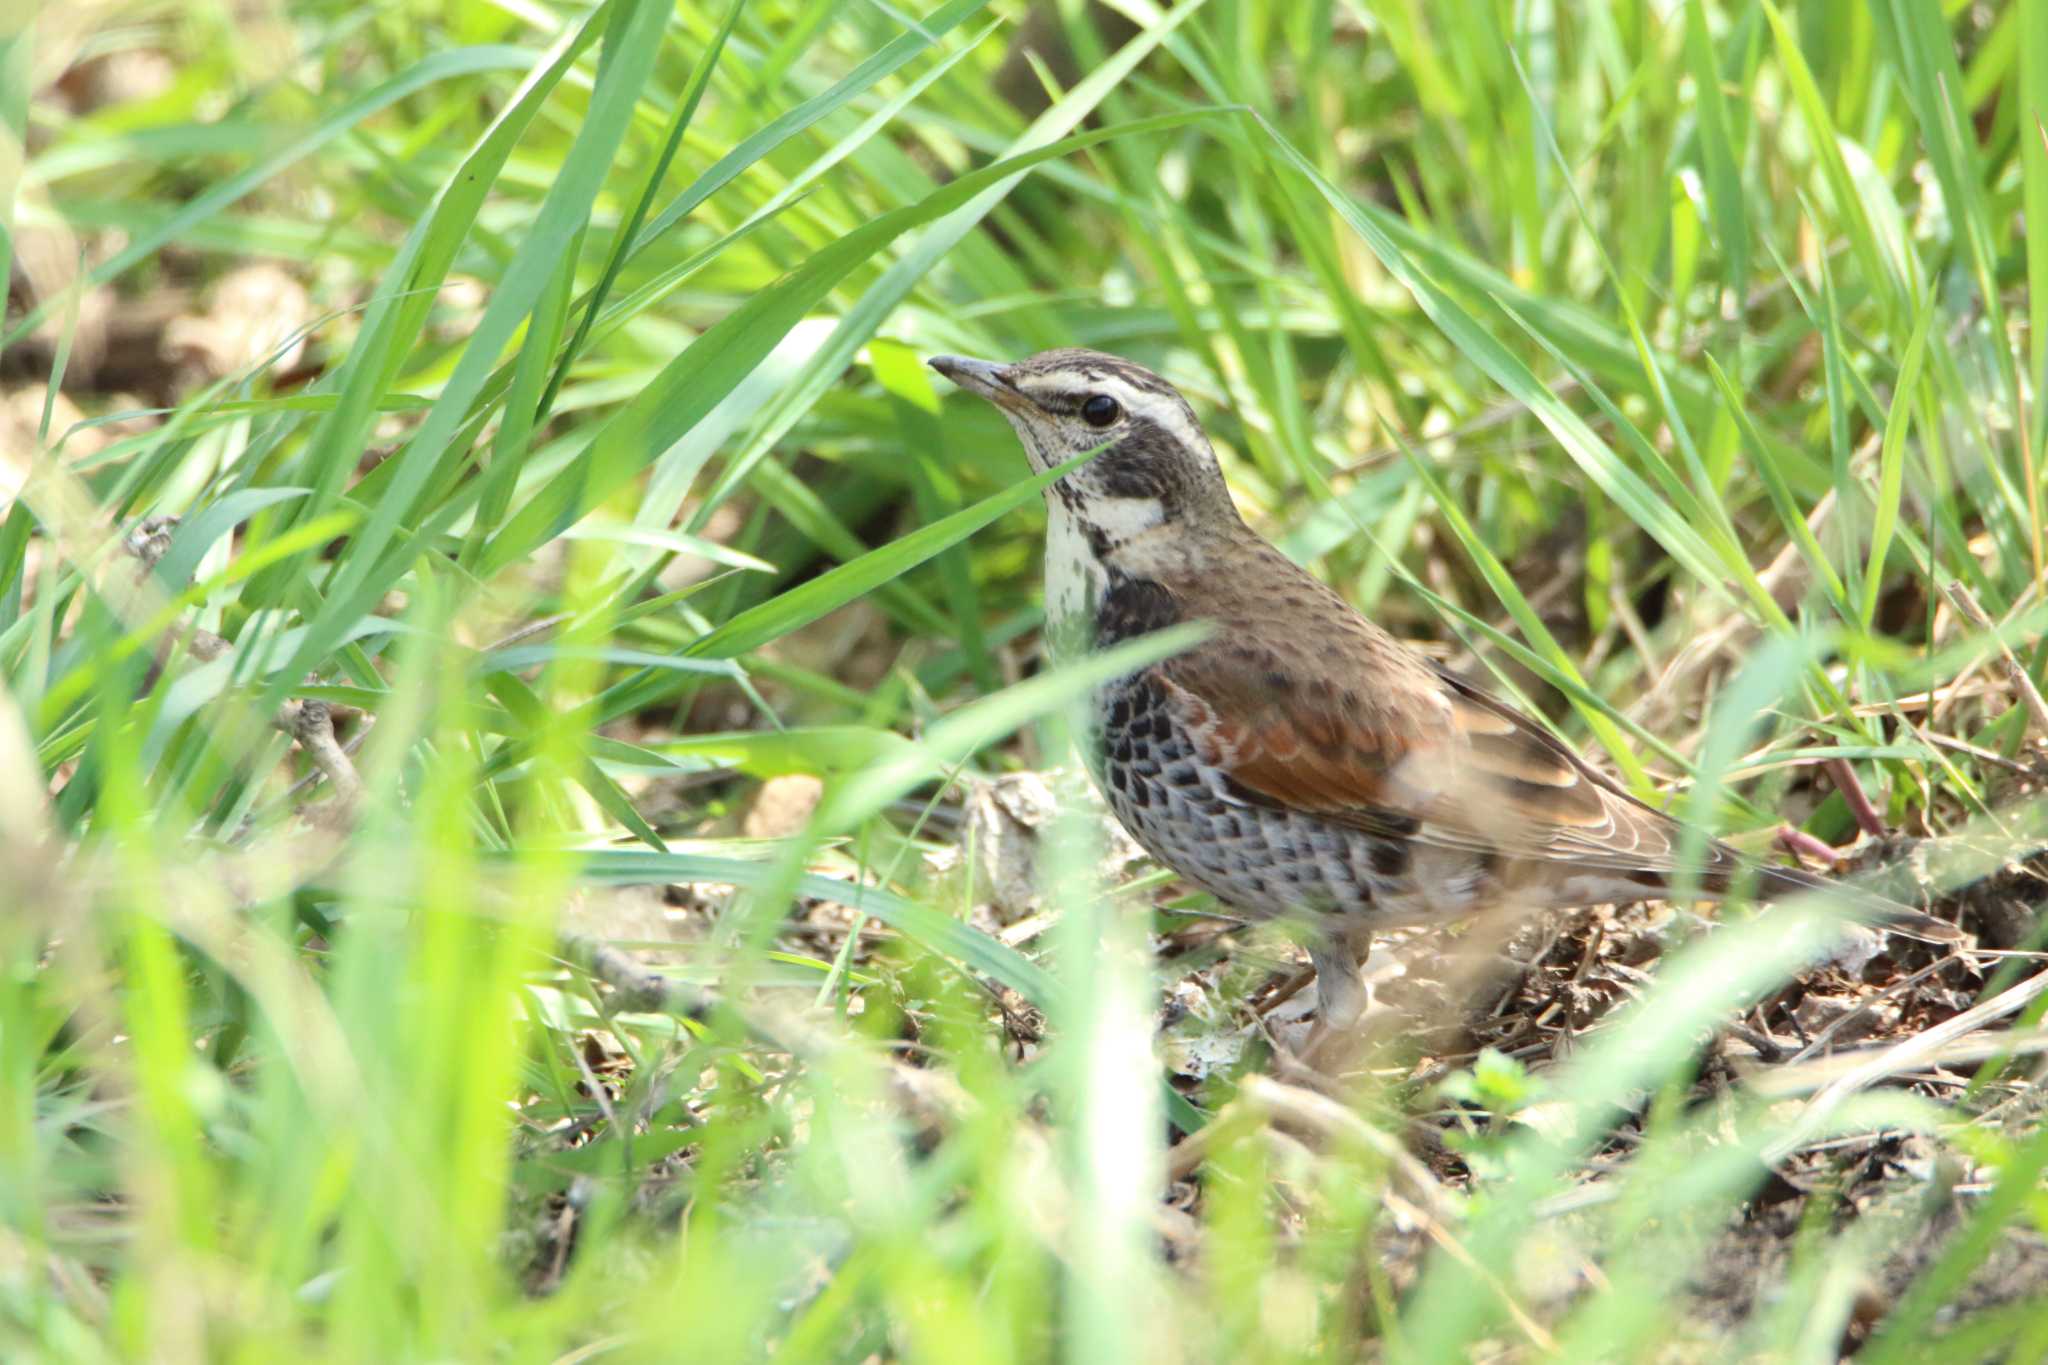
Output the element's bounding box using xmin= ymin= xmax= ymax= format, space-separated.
xmin=1159 ymin=632 xmax=1703 ymax=872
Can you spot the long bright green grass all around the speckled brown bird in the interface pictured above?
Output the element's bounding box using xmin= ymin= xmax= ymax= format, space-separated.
xmin=0 ymin=0 xmax=2048 ymax=1361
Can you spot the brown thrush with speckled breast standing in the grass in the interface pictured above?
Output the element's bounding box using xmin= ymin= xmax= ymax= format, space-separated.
xmin=930 ymin=348 xmax=1966 ymax=1031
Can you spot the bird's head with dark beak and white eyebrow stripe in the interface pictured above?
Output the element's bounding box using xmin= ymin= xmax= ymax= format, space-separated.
xmin=932 ymin=350 xmax=1239 ymax=544
